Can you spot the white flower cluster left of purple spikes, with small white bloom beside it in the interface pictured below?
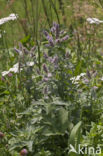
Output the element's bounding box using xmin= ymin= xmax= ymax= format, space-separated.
xmin=1 ymin=62 xmax=34 ymax=77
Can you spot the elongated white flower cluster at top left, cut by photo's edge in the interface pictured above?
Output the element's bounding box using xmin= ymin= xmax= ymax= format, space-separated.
xmin=0 ymin=13 xmax=18 ymax=25
